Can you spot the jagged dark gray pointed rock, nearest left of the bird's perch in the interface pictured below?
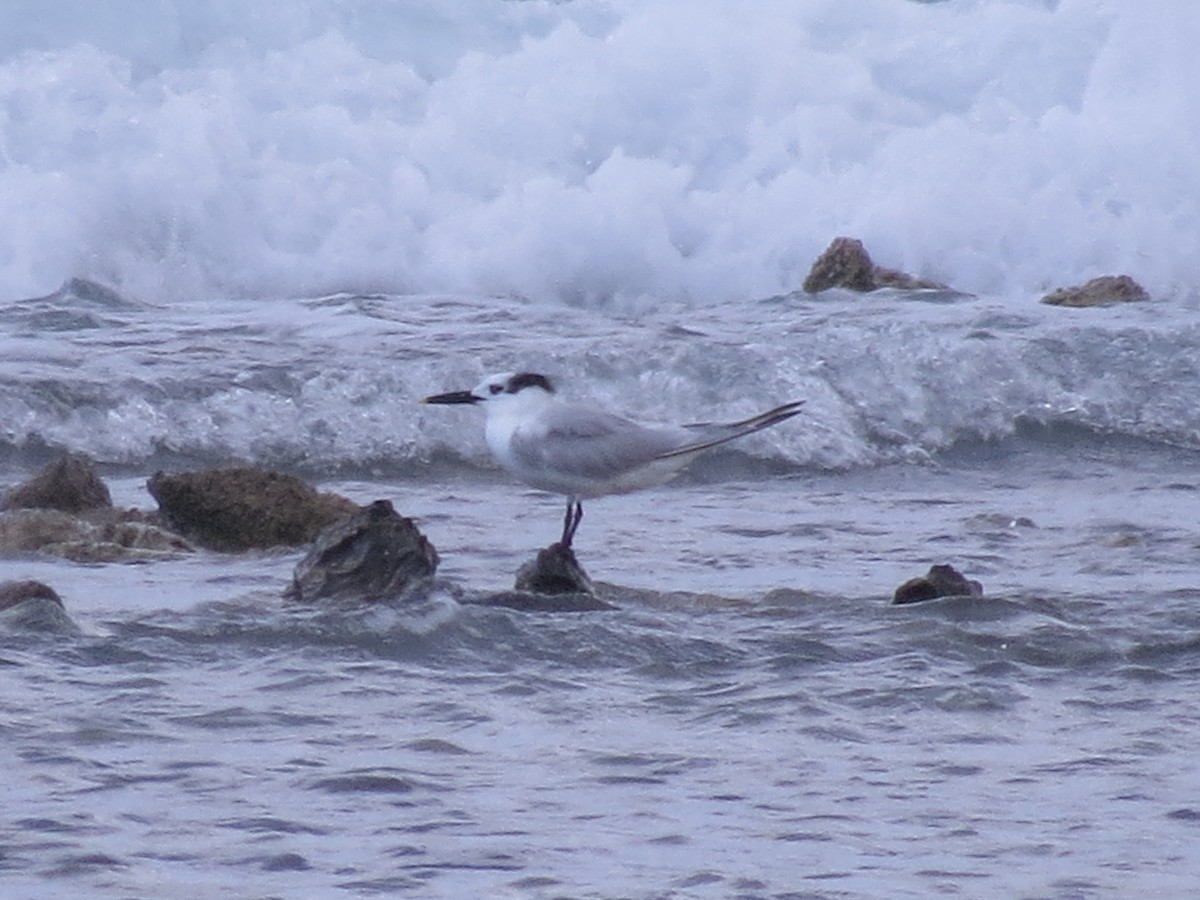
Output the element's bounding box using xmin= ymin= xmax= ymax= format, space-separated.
xmin=283 ymin=500 xmax=438 ymax=602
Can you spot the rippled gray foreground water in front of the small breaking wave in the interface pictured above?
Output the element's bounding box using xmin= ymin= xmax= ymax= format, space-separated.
xmin=7 ymin=430 xmax=1200 ymax=898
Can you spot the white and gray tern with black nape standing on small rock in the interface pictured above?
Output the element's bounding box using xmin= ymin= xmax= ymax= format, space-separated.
xmin=421 ymin=372 xmax=804 ymax=550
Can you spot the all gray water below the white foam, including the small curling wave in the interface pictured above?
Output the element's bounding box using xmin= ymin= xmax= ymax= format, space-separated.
xmin=0 ymin=284 xmax=1200 ymax=900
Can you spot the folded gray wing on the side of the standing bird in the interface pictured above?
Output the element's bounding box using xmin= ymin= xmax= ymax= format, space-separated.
xmin=512 ymin=406 xmax=688 ymax=479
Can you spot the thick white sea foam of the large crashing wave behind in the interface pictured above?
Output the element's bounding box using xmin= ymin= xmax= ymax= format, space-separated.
xmin=0 ymin=0 xmax=1200 ymax=308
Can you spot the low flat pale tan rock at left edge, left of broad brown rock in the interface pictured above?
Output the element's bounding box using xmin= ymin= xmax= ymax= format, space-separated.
xmin=0 ymin=509 xmax=193 ymax=563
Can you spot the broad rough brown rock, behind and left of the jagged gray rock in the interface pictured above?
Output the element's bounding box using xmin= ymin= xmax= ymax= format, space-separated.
xmin=146 ymin=466 xmax=359 ymax=552
